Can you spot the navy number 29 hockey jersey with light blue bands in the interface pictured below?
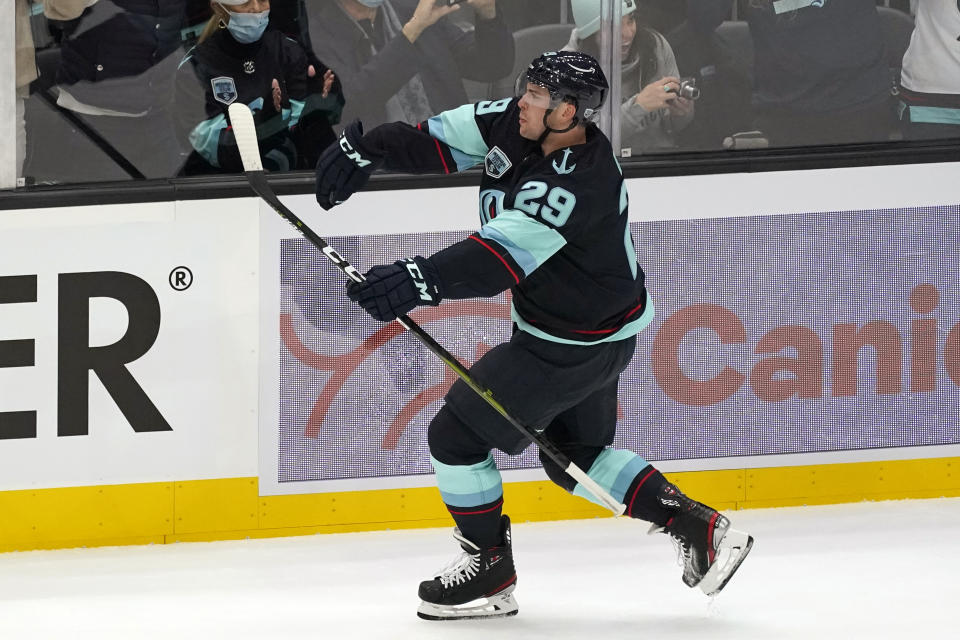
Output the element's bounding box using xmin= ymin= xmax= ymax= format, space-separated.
xmin=363 ymin=98 xmax=653 ymax=345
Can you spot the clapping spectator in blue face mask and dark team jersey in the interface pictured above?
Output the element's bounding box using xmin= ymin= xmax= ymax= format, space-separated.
xmin=177 ymin=0 xmax=343 ymax=175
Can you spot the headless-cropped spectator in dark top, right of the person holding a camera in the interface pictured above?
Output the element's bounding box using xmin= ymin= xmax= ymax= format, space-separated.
xmin=687 ymin=0 xmax=892 ymax=146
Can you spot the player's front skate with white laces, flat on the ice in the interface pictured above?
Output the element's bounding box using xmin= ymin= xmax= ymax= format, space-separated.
xmin=417 ymin=516 xmax=517 ymax=620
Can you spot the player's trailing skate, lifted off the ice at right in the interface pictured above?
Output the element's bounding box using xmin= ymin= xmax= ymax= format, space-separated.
xmin=650 ymin=484 xmax=753 ymax=596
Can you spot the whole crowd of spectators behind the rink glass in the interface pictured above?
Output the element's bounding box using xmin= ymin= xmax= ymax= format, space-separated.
xmin=14 ymin=0 xmax=960 ymax=186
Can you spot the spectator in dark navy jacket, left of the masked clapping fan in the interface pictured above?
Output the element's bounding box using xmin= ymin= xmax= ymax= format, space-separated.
xmin=43 ymin=0 xmax=185 ymax=178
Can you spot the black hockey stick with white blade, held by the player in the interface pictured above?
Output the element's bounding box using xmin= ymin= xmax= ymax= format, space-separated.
xmin=228 ymin=102 xmax=626 ymax=516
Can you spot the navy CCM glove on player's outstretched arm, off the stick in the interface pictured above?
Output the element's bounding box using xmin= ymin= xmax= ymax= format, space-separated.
xmin=317 ymin=120 xmax=383 ymax=211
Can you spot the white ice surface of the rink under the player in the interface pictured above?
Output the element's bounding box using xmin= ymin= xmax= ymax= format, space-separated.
xmin=0 ymin=499 xmax=960 ymax=640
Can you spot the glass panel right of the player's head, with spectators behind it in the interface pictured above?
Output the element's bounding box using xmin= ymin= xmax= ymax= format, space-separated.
xmin=636 ymin=0 xmax=960 ymax=153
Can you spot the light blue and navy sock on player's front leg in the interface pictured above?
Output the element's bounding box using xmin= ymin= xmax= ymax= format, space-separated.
xmin=430 ymin=455 xmax=503 ymax=549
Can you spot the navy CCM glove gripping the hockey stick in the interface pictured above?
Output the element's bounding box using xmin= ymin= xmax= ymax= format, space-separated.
xmin=347 ymin=256 xmax=443 ymax=322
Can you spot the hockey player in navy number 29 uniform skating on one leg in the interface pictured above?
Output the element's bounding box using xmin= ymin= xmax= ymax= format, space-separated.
xmin=317 ymin=52 xmax=753 ymax=620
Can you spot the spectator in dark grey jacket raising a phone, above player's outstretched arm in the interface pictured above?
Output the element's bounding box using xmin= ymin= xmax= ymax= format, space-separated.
xmin=307 ymin=0 xmax=513 ymax=127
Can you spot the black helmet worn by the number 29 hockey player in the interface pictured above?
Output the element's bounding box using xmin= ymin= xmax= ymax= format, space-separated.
xmin=517 ymin=51 xmax=610 ymax=121
